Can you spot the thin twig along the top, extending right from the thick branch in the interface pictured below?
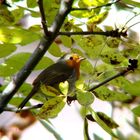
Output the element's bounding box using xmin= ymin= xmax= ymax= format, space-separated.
xmin=72 ymin=0 xmax=120 ymax=11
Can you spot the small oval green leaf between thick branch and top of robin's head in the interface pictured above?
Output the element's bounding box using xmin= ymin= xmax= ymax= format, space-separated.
xmin=48 ymin=43 xmax=61 ymax=57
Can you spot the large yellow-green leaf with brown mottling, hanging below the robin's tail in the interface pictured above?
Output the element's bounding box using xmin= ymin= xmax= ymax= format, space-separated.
xmin=37 ymin=96 xmax=66 ymax=119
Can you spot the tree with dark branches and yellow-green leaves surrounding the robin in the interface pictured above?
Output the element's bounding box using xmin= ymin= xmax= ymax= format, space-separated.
xmin=0 ymin=0 xmax=140 ymax=139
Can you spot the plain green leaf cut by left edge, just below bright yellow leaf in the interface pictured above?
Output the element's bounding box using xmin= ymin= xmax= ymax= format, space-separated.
xmin=0 ymin=44 xmax=16 ymax=58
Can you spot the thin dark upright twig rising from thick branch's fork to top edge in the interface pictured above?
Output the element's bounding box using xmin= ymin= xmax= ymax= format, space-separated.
xmin=37 ymin=0 xmax=49 ymax=36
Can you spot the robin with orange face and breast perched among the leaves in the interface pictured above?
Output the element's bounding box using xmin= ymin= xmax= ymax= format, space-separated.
xmin=19 ymin=53 xmax=84 ymax=109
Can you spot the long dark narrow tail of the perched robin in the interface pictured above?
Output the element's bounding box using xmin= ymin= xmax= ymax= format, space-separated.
xmin=18 ymin=87 xmax=37 ymax=110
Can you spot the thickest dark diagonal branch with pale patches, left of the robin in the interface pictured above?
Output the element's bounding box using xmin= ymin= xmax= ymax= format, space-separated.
xmin=0 ymin=0 xmax=74 ymax=113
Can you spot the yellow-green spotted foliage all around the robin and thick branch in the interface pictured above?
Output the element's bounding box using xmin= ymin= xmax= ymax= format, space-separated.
xmin=0 ymin=0 xmax=140 ymax=139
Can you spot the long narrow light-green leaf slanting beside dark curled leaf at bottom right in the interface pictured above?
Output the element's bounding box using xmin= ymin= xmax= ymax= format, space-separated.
xmin=89 ymin=107 xmax=117 ymax=138
